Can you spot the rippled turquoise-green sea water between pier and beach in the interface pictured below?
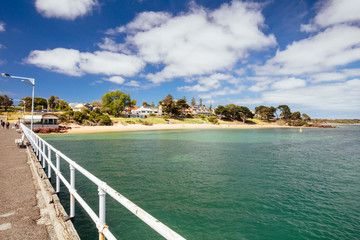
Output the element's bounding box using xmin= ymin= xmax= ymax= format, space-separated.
xmin=43 ymin=126 xmax=360 ymax=239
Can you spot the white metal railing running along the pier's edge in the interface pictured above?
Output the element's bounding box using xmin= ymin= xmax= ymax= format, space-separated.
xmin=21 ymin=124 xmax=185 ymax=240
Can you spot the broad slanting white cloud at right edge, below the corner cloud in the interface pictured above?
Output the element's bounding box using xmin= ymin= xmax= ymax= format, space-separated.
xmin=255 ymin=25 xmax=360 ymax=75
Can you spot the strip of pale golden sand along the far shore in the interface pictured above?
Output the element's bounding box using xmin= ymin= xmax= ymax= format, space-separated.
xmin=64 ymin=123 xmax=289 ymax=133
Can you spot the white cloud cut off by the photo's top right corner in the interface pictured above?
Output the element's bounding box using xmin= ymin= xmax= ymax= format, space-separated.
xmin=301 ymin=0 xmax=360 ymax=32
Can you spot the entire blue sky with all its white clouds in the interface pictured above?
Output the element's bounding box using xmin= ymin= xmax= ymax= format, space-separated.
xmin=0 ymin=0 xmax=360 ymax=118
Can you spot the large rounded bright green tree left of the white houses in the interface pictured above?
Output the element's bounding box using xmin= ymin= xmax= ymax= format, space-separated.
xmin=101 ymin=91 xmax=136 ymax=117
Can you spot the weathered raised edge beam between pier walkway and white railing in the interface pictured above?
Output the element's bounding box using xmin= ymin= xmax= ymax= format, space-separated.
xmin=27 ymin=140 xmax=80 ymax=240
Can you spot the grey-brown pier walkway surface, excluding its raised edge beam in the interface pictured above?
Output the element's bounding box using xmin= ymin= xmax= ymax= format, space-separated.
xmin=0 ymin=126 xmax=51 ymax=239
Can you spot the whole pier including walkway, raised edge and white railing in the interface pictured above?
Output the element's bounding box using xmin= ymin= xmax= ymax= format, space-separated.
xmin=0 ymin=124 xmax=185 ymax=240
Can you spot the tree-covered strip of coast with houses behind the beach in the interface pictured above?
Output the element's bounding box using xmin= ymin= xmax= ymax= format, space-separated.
xmin=0 ymin=91 xmax=360 ymax=127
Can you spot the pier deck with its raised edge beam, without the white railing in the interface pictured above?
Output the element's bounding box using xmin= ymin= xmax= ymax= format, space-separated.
xmin=0 ymin=128 xmax=79 ymax=240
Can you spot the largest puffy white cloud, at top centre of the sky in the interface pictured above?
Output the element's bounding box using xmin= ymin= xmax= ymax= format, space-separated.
xmin=116 ymin=1 xmax=276 ymax=83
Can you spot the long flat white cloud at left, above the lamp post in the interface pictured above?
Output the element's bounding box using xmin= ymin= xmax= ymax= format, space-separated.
xmin=25 ymin=48 xmax=144 ymax=76
